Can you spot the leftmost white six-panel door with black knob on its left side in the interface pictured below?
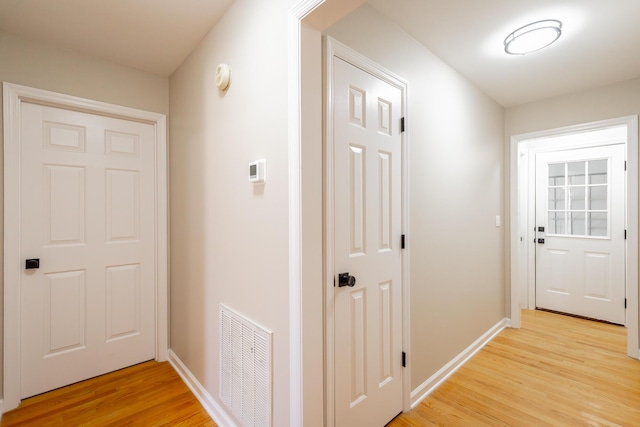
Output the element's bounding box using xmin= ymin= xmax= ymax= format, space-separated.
xmin=20 ymin=103 xmax=156 ymax=398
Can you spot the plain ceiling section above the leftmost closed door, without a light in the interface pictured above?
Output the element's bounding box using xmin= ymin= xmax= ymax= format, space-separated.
xmin=0 ymin=0 xmax=233 ymax=77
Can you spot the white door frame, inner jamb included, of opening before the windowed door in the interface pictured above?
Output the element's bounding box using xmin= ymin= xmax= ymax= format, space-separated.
xmin=510 ymin=116 xmax=640 ymax=359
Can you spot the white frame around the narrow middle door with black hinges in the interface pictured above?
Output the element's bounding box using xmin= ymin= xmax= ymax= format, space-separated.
xmin=324 ymin=37 xmax=411 ymax=427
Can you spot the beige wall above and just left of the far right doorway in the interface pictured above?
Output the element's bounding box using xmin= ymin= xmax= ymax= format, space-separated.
xmin=504 ymin=79 xmax=640 ymax=344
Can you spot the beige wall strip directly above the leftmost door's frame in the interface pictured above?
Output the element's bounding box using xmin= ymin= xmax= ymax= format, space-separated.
xmin=0 ymin=31 xmax=169 ymax=398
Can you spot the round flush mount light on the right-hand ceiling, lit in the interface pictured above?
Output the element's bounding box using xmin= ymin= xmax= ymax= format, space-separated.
xmin=504 ymin=19 xmax=562 ymax=55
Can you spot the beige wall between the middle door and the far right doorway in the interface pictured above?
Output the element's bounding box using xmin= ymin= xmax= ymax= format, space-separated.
xmin=326 ymin=5 xmax=504 ymax=389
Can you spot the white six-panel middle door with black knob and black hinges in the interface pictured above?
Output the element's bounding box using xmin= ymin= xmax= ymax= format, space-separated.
xmin=333 ymin=58 xmax=402 ymax=427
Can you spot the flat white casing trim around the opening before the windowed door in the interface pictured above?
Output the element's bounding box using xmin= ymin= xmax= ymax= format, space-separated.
xmin=510 ymin=116 xmax=640 ymax=359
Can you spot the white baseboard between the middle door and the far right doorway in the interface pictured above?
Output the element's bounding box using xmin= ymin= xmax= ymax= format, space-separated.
xmin=411 ymin=318 xmax=510 ymax=409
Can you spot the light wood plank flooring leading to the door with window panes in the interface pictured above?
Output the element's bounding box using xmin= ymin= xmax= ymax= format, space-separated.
xmin=388 ymin=310 xmax=640 ymax=427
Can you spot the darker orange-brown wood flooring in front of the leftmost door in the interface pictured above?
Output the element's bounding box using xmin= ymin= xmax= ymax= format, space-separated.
xmin=0 ymin=361 xmax=216 ymax=427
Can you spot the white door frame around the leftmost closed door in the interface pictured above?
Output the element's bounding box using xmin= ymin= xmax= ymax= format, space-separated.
xmin=2 ymin=82 xmax=168 ymax=412
